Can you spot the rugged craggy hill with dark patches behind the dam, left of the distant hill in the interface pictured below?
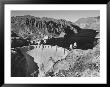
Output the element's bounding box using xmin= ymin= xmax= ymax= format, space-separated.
xmin=11 ymin=15 xmax=80 ymax=40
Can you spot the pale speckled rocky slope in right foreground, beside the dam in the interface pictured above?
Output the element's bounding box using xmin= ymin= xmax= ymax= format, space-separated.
xmin=51 ymin=39 xmax=100 ymax=77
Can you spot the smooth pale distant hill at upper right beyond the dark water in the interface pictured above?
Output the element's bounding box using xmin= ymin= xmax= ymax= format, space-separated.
xmin=75 ymin=16 xmax=100 ymax=31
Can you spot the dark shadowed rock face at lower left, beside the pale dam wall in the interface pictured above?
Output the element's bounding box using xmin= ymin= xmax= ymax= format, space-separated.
xmin=11 ymin=48 xmax=39 ymax=77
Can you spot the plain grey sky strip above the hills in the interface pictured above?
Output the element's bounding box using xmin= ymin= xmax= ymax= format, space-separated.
xmin=11 ymin=10 xmax=100 ymax=22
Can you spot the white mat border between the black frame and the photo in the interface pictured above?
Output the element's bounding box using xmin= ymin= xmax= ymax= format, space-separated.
xmin=4 ymin=4 xmax=107 ymax=84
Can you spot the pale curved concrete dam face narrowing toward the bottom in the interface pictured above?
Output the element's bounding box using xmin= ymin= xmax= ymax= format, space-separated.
xmin=27 ymin=45 xmax=68 ymax=76
